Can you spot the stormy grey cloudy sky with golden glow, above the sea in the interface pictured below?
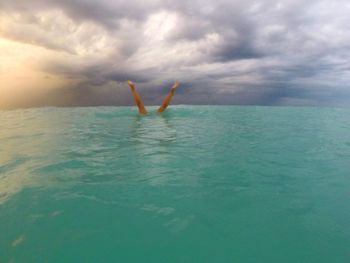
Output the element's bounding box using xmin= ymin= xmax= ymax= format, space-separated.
xmin=0 ymin=0 xmax=350 ymax=108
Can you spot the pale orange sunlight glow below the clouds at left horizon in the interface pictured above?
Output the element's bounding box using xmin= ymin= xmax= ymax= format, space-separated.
xmin=0 ymin=36 xmax=74 ymax=108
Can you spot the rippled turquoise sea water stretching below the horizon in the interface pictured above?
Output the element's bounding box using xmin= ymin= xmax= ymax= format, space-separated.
xmin=0 ymin=106 xmax=350 ymax=263
